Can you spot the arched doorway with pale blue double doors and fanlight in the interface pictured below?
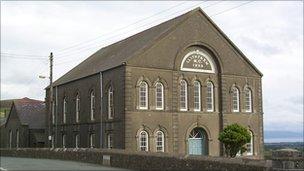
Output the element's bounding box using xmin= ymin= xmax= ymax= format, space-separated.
xmin=188 ymin=128 xmax=208 ymax=155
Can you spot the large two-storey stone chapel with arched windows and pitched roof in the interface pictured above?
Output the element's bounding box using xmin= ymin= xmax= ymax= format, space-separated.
xmin=46 ymin=8 xmax=263 ymax=158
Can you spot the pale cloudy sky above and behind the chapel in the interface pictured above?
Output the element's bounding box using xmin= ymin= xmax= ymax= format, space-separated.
xmin=1 ymin=1 xmax=303 ymax=142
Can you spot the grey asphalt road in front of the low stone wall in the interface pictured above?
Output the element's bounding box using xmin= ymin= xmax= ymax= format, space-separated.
xmin=0 ymin=156 xmax=127 ymax=171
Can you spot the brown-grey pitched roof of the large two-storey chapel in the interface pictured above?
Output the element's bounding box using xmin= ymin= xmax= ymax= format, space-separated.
xmin=53 ymin=8 xmax=262 ymax=86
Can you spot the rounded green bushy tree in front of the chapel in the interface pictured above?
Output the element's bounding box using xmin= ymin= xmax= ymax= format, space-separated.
xmin=218 ymin=124 xmax=251 ymax=157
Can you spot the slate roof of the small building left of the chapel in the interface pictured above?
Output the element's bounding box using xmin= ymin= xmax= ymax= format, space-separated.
xmin=7 ymin=97 xmax=46 ymax=129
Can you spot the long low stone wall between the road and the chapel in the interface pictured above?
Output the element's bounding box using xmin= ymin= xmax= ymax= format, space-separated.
xmin=0 ymin=148 xmax=272 ymax=171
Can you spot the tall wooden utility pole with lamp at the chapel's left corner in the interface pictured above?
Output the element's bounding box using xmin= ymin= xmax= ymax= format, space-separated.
xmin=49 ymin=52 xmax=54 ymax=148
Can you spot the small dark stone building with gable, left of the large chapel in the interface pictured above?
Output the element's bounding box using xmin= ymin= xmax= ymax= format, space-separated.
xmin=1 ymin=97 xmax=46 ymax=148
